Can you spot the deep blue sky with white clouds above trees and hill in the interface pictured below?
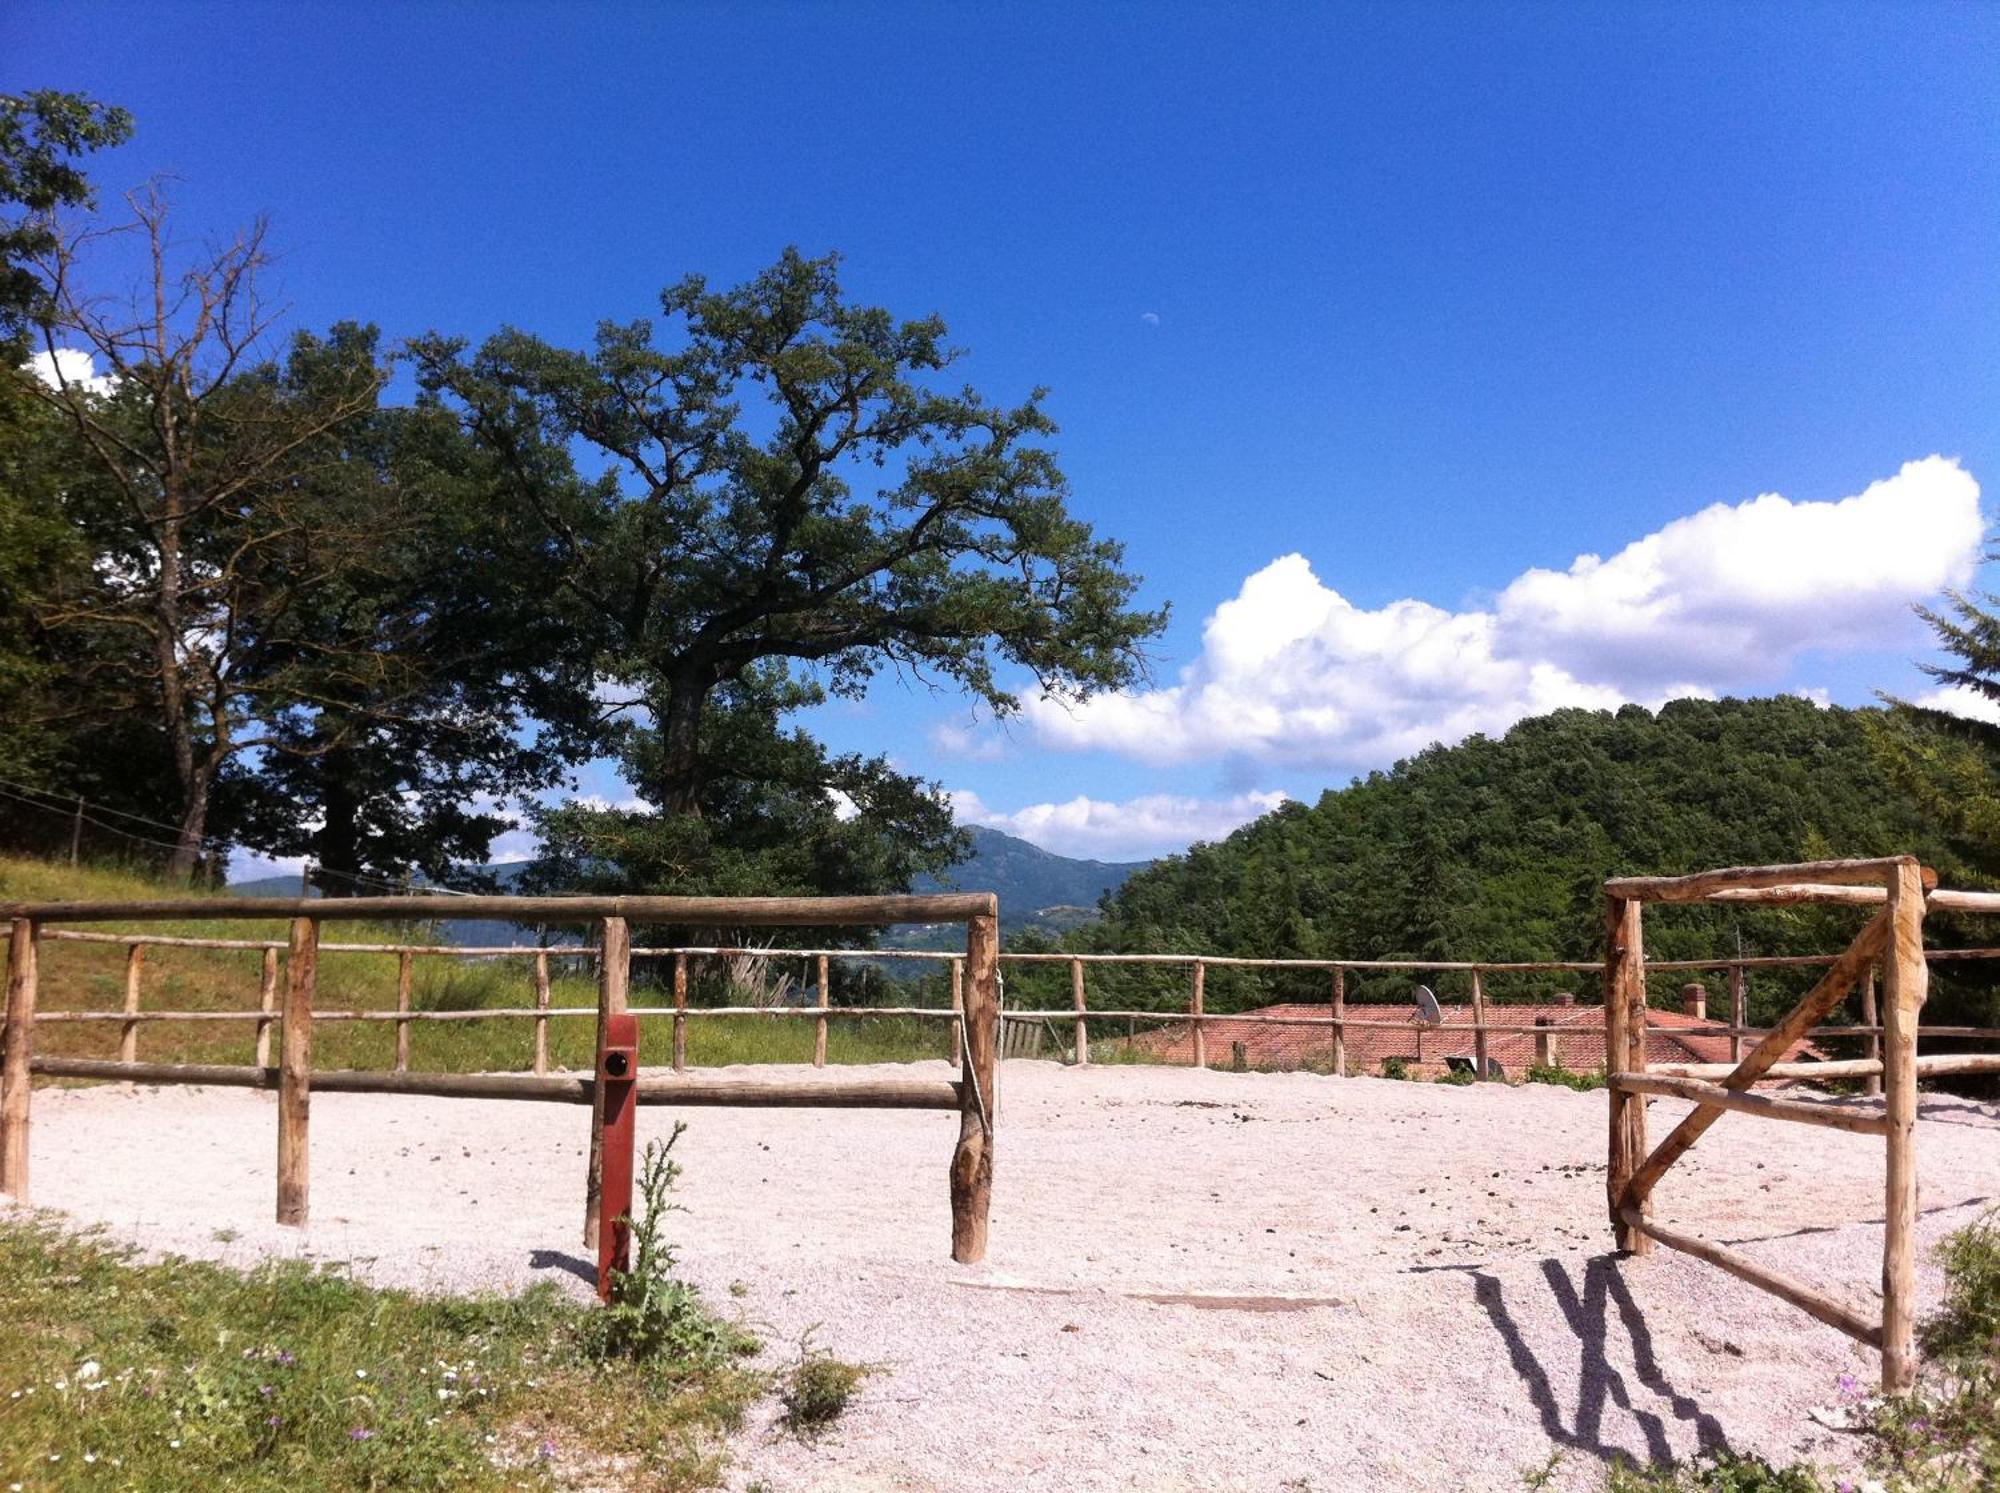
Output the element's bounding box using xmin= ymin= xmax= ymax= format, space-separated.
xmin=15 ymin=0 xmax=2000 ymax=859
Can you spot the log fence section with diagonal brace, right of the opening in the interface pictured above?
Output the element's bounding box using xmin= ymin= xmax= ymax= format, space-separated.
xmin=1604 ymin=857 xmax=2000 ymax=1393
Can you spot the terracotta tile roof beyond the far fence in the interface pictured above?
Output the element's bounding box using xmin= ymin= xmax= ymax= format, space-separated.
xmin=1138 ymin=1003 xmax=1826 ymax=1079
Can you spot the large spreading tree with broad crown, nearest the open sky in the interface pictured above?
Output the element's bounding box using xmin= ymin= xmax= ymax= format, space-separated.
xmin=414 ymin=250 xmax=1164 ymax=893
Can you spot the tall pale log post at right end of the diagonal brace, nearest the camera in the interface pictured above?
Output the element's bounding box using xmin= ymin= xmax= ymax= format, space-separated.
xmin=1882 ymin=859 xmax=1930 ymax=1395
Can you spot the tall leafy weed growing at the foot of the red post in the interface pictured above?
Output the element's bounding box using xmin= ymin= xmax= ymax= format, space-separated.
xmin=584 ymin=1121 xmax=758 ymax=1375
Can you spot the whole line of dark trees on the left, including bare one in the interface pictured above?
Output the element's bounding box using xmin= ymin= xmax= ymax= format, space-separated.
xmin=0 ymin=92 xmax=1164 ymax=895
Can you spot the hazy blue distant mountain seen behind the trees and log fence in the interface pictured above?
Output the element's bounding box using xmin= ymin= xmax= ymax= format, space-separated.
xmin=230 ymin=825 xmax=1152 ymax=949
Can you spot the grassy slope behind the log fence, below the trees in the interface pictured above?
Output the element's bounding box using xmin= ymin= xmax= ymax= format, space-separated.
xmin=0 ymin=857 xmax=948 ymax=1073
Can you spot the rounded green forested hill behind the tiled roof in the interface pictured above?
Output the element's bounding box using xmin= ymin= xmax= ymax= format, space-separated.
xmin=1076 ymin=696 xmax=1968 ymax=961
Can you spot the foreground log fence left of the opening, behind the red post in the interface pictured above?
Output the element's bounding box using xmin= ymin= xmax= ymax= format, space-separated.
xmin=0 ymin=893 xmax=1000 ymax=1263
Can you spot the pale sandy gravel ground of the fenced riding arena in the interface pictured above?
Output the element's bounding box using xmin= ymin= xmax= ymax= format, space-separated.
xmin=15 ymin=1063 xmax=2000 ymax=1493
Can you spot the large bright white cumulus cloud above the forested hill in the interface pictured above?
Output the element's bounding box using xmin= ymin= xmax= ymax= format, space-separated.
xmin=1026 ymin=456 xmax=1984 ymax=769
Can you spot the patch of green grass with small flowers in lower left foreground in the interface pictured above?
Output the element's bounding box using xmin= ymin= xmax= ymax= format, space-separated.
xmin=0 ymin=1221 xmax=770 ymax=1493
